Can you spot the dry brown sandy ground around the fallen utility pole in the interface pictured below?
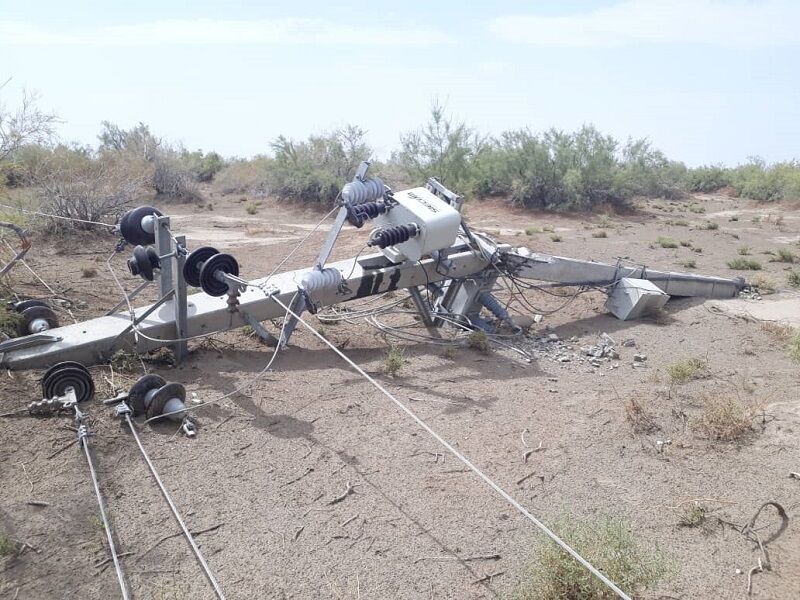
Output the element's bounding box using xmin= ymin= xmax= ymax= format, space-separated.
xmin=0 ymin=189 xmax=800 ymax=600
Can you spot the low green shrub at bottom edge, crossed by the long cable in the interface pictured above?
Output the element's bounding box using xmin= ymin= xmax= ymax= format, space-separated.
xmin=511 ymin=516 xmax=671 ymax=600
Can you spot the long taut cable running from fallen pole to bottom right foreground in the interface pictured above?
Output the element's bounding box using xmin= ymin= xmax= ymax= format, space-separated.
xmin=271 ymin=295 xmax=631 ymax=600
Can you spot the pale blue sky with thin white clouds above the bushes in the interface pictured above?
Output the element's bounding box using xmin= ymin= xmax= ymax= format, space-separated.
xmin=0 ymin=0 xmax=800 ymax=165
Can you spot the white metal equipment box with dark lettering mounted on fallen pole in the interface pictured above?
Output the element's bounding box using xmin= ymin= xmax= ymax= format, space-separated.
xmin=373 ymin=187 xmax=461 ymax=263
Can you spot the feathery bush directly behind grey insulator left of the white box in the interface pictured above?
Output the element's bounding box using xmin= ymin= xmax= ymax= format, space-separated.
xmin=267 ymin=125 xmax=372 ymax=204
